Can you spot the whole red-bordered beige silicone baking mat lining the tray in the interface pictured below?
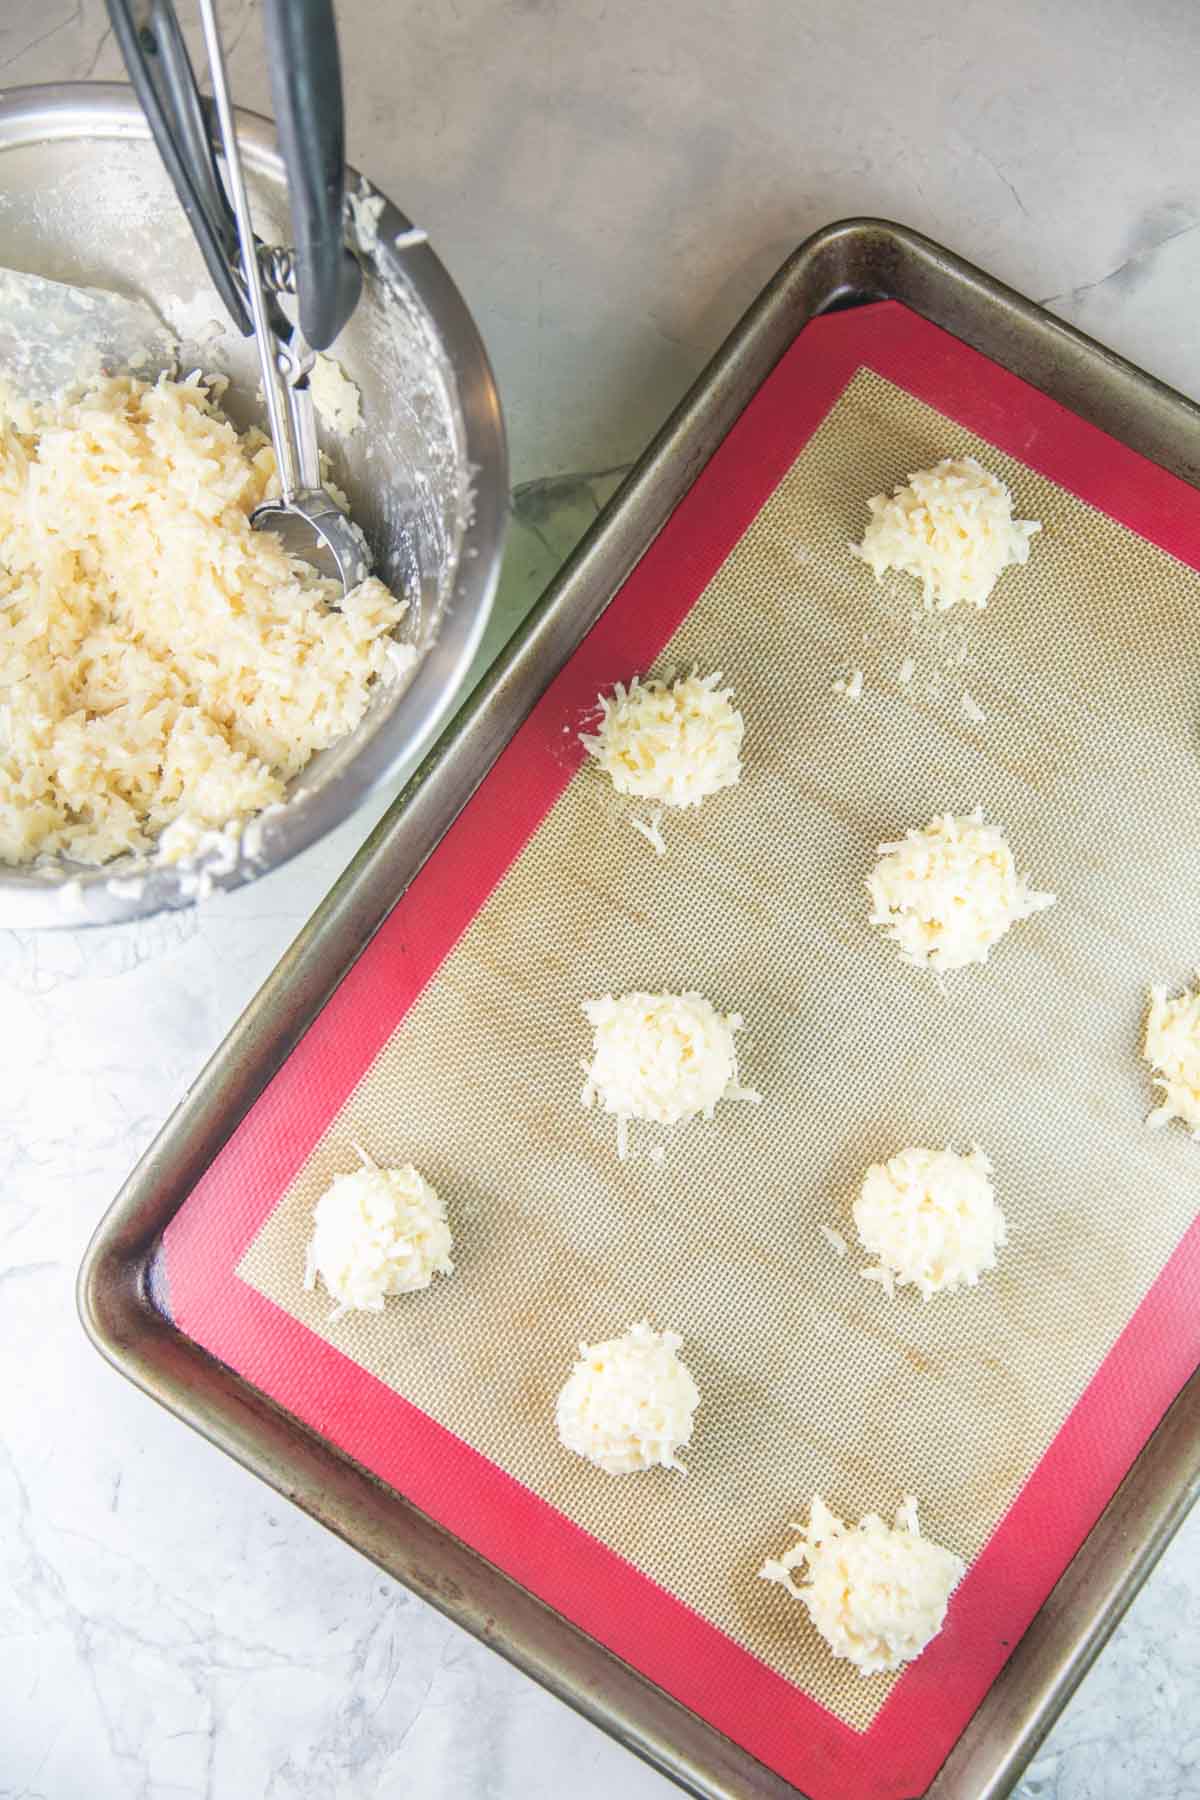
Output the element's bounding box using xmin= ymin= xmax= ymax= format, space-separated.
xmin=166 ymin=302 xmax=1200 ymax=1800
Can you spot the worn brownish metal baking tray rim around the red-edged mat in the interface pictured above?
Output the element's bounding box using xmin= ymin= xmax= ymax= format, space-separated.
xmin=79 ymin=220 xmax=1200 ymax=1800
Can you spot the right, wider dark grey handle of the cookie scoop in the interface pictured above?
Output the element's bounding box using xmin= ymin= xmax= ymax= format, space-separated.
xmin=263 ymin=0 xmax=362 ymax=349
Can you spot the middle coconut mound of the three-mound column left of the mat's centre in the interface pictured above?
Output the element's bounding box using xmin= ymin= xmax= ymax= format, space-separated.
xmin=581 ymin=992 xmax=759 ymax=1157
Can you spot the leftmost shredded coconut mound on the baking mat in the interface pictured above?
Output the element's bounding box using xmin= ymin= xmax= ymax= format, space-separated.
xmin=304 ymin=1150 xmax=453 ymax=1321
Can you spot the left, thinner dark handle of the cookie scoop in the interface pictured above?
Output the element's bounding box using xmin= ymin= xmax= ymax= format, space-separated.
xmin=106 ymin=0 xmax=254 ymax=337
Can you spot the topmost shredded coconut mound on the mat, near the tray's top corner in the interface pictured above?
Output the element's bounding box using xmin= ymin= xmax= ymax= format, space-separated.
xmin=851 ymin=455 xmax=1042 ymax=612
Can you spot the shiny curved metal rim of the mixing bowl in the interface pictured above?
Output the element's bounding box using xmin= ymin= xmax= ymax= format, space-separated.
xmin=0 ymin=81 xmax=509 ymax=929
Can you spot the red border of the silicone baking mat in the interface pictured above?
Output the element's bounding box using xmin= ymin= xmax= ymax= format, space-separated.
xmin=166 ymin=301 xmax=1200 ymax=1800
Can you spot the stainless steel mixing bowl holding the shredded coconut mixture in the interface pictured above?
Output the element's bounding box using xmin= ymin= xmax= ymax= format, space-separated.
xmin=0 ymin=83 xmax=507 ymax=927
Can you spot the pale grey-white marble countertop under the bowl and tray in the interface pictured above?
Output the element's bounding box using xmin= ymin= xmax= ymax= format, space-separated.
xmin=0 ymin=0 xmax=1200 ymax=1800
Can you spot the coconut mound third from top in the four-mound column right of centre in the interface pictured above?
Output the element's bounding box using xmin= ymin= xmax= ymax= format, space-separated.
xmin=855 ymin=1147 xmax=1007 ymax=1300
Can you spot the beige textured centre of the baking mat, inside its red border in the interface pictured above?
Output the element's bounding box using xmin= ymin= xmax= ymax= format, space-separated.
xmin=239 ymin=371 xmax=1200 ymax=1728
